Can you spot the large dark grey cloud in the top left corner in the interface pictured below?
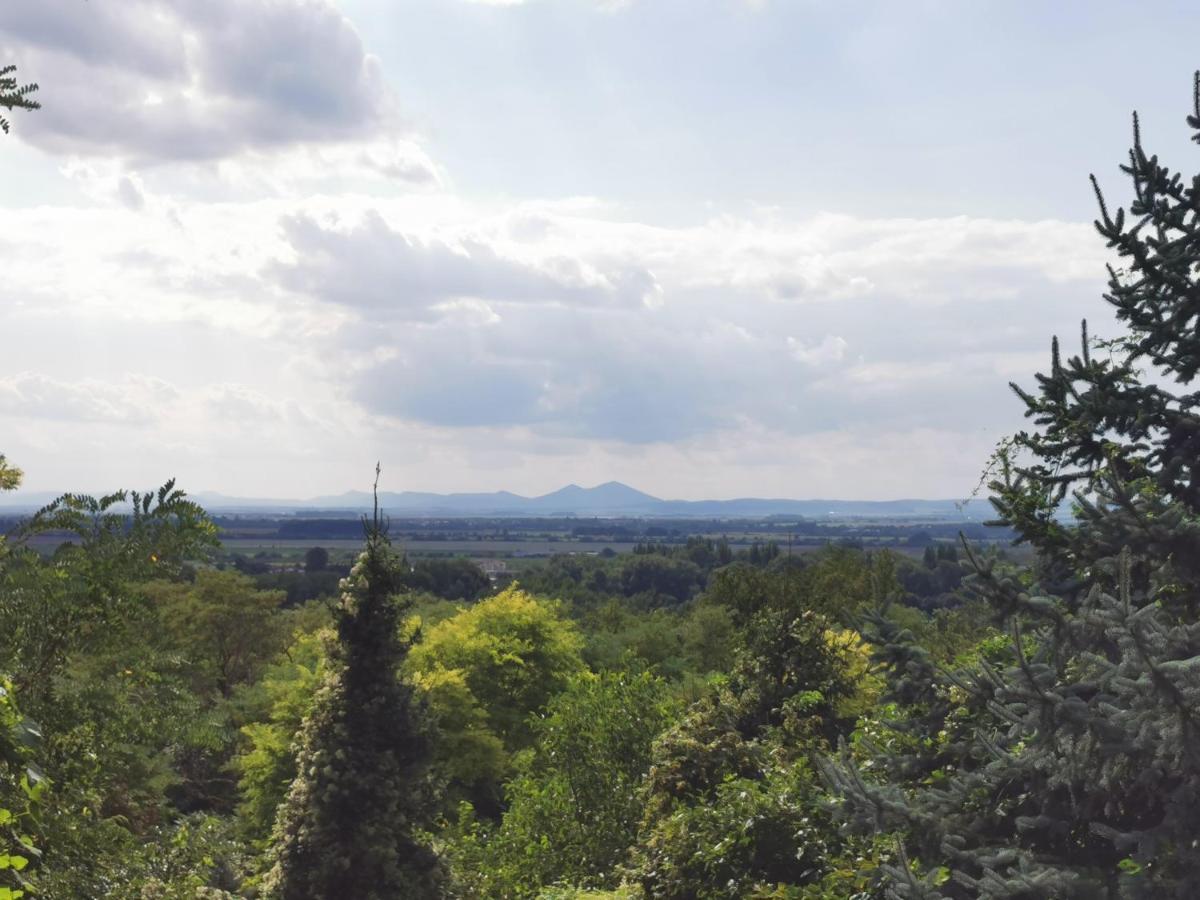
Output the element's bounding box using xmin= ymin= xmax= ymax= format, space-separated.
xmin=0 ymin=0 xmax=394 ymax=163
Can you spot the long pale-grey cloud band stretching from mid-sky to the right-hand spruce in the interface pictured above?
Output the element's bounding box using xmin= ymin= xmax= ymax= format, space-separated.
xmin=336 ymin=237 xmax=1094 ymax=446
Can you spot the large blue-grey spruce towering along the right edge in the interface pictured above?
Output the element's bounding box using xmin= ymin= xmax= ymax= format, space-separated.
xmin=824 ymin=72 xmax=1200 ymax=900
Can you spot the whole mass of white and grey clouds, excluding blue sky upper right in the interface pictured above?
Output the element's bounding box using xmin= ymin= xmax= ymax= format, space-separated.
xmin=0 ymin=0 xmax=1104 ymax=498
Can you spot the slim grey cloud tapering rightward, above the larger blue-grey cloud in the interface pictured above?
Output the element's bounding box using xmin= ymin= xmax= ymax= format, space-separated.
xmin=274 ymin=214 xmax=658 ymax=319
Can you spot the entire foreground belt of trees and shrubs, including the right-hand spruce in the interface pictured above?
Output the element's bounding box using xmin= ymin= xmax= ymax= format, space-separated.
xmin=7 ymin=61 xmax=1200 ymax=900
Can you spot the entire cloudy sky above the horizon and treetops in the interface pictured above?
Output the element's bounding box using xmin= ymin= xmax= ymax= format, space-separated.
xmin=0 ymin=0 xmax=1200 ymax=499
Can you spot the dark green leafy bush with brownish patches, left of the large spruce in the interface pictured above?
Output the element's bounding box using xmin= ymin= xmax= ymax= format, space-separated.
xmin=630 ymin=600 xmax=857 ymax=899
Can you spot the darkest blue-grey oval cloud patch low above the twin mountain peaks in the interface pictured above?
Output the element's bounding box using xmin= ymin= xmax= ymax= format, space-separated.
xmin=354 ymin=307 xmax=753 ymax=444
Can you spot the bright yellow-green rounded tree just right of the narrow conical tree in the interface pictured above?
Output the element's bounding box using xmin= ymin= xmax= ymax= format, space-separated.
xmin=407 ymin=586 xmax=583 ymax=751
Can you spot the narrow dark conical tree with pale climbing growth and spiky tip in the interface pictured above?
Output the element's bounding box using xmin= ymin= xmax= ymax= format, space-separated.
xmin=264 ymin=468 xmax=443 ymax=900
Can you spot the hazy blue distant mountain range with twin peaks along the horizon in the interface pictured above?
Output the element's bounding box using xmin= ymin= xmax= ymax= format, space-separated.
xmin=0 ymin=481 xmax=991 ymax=521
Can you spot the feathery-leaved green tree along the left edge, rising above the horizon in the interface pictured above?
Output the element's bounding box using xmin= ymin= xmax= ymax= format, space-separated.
xmin=0 ymin=467 xmax=250 ymax=896
